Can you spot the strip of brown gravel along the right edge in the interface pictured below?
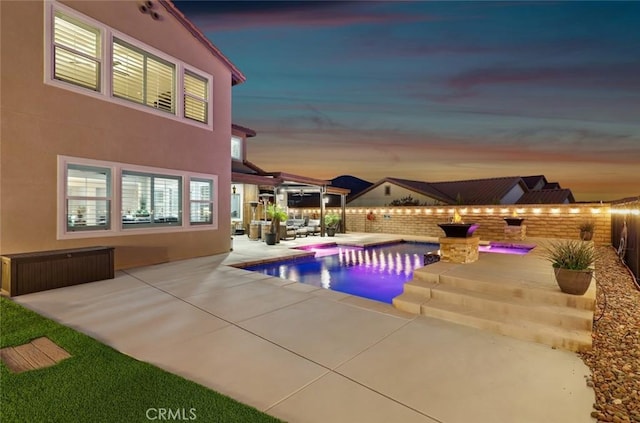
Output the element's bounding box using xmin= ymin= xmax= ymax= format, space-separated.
xmin=580 ymin=247 xmax=640 ymax=423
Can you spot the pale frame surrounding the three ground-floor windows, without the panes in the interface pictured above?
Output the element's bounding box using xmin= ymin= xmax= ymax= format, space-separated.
xmin=57 ymin=156 xmax=220 ymax=240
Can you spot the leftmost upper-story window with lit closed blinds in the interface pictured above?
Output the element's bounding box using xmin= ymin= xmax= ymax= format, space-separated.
xmin=53 ymin=11 xmax=102 ymax=91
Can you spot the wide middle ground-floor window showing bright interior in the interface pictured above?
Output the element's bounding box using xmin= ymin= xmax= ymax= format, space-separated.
xmin=121 ymin=171 xmax=182 ymax=228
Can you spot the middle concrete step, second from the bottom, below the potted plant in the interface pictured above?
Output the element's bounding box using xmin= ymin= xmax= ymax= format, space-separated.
xmin=430 ymin=284 xmax=593 ymax=331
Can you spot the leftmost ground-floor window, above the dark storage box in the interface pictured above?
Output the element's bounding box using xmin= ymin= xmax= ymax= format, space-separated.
xmin=65 ymin=164 xmax=111 ymax=231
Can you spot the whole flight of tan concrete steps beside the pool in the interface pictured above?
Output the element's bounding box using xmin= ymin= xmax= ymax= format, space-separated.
xmin=393 ymin=263 xmax=595 ymax=351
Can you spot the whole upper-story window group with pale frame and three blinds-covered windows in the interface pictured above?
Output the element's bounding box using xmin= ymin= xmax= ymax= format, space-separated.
xmin=45 ymin=1 xmax=213 ymax=130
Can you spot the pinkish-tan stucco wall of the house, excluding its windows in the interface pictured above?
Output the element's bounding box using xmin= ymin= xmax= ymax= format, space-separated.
xmin=0 ymin=1 xmax=231 ymax=268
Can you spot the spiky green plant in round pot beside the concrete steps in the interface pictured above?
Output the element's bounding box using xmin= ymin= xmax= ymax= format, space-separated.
xmin=543 ymin=240 xmax=596 ymax=295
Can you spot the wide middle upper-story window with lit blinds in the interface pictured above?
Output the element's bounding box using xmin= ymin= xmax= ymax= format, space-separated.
xmin=112 ymin=38 xmax=176 ymax=114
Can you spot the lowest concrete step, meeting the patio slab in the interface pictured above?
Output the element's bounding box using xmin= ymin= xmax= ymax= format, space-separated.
xmin=420 ymin=299 xmax=592 ymax=351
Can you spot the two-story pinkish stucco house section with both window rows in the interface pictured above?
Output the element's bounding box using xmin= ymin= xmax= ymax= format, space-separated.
xmin=0 ymin=0 xmax=245 ymax=269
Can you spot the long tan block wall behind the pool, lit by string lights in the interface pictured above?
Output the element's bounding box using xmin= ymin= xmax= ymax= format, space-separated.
xmin=296 ymin=203 xmax=611 ymax=244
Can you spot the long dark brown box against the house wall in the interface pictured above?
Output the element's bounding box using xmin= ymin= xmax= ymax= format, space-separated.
xmin=2 ymin=247 xmax=114 ymax=296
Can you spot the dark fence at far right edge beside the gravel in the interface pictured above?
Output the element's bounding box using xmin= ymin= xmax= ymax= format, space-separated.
xmin=611 ymin=197 xmax=640 ymax=281
